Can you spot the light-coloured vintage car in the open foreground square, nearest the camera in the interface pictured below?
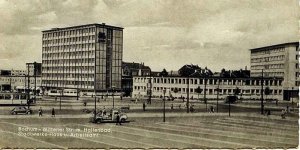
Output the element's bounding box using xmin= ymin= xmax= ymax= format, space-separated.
xmin=90 ymin=109 xmax=128 ymax=123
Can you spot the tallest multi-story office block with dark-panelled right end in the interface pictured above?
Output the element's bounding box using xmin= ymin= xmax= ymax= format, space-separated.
xmin=42 ymin=24 xmax=123 ymax=92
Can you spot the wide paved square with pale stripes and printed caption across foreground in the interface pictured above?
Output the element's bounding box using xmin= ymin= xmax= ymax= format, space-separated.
xmin=0 ymin=96 xmax=298 ymax=148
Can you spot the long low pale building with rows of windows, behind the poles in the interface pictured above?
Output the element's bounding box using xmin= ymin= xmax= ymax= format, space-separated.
xmin=132 ymin=76 xmax=283 ymax=100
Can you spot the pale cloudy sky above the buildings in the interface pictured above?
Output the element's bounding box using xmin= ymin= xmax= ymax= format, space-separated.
xmin=0 ymin=0 xmax=300 ymax=71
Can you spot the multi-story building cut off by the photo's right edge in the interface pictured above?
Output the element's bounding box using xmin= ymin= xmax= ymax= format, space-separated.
xmin=250 ymin=42 xmax=300 ymax=99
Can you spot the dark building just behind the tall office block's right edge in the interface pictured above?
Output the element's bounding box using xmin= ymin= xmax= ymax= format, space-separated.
xmin=122 ymin=62 xmax=151 ymax=96
